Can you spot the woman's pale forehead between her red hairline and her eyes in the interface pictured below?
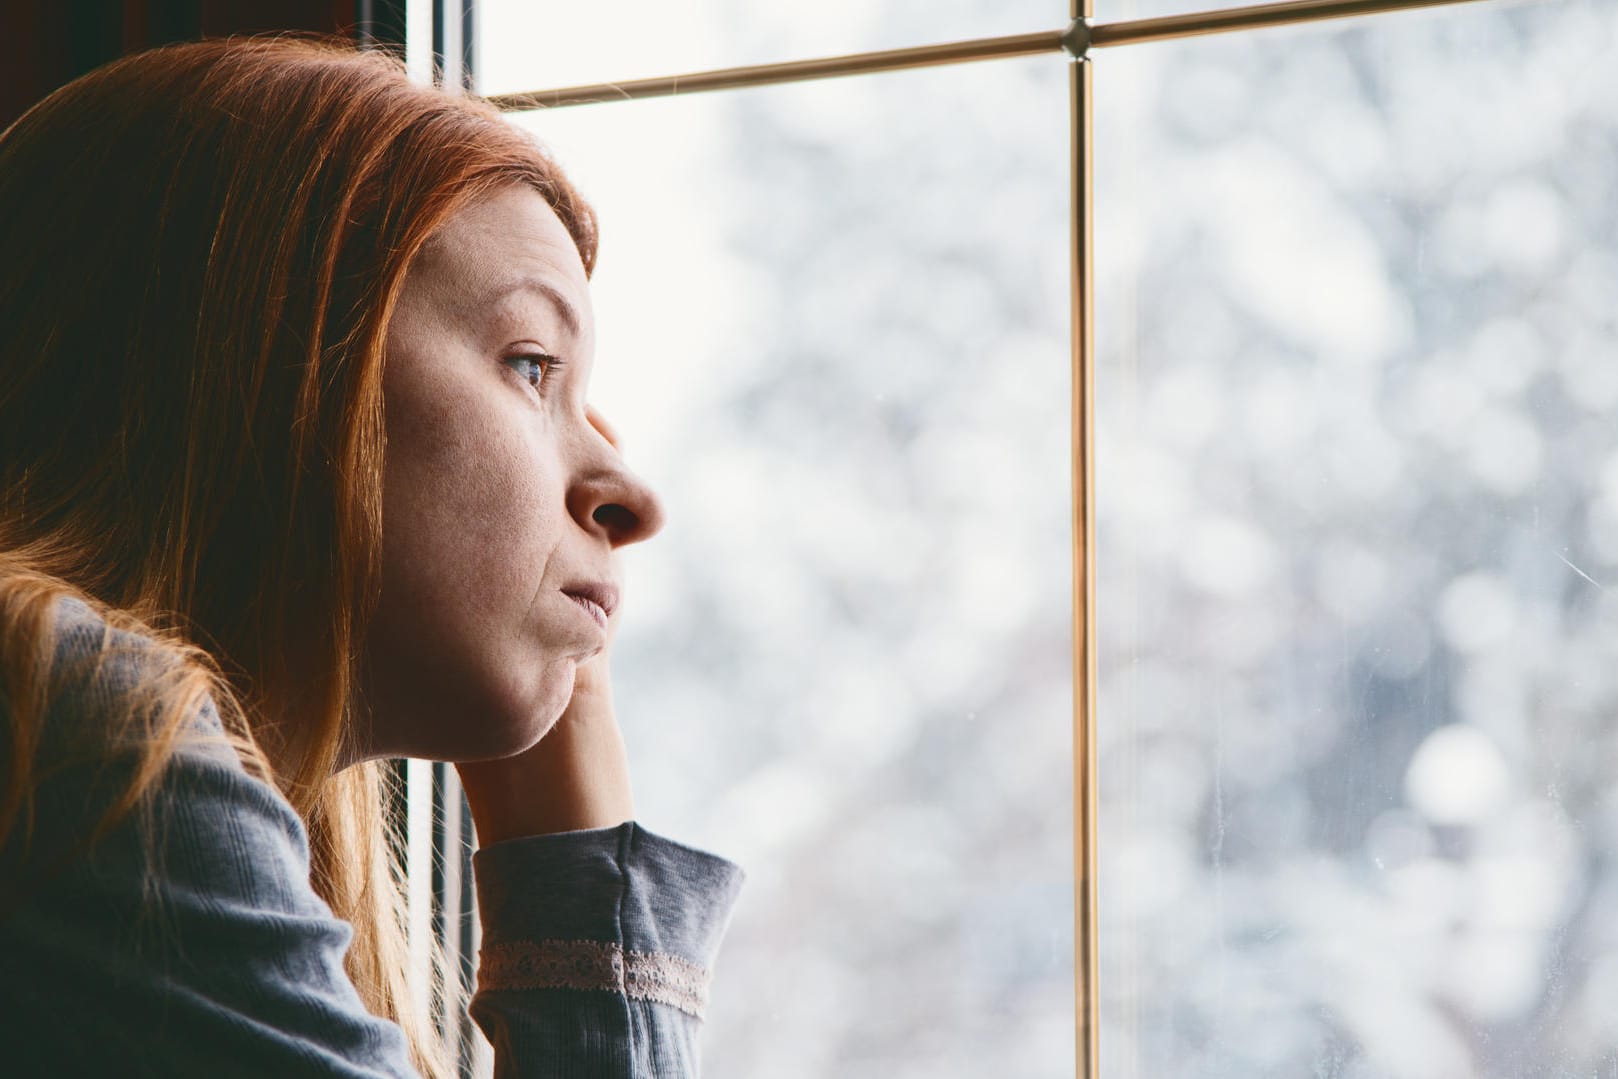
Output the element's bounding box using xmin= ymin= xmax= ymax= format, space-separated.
xmin=406 ymin=188 xmax=591 ymax=336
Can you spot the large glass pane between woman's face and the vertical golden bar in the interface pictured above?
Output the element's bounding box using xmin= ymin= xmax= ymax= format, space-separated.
xmin=501 ymin=55 xmax=1074 ymax=1079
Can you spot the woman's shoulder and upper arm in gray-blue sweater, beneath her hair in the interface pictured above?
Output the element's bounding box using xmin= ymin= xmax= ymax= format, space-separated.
xmin=0 ymin=603 xmax=413 ymax=1076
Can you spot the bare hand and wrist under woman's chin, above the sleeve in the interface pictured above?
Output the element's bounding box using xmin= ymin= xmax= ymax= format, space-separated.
xmin=455 ymin=556 xmax=634 ymax=846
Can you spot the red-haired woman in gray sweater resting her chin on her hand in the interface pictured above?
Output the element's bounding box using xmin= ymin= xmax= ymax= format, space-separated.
xmin=0 ymin=39 xmax=741 ymax=1076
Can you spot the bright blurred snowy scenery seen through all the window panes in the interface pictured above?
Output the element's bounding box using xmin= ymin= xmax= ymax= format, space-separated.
xmin=477 ymin=0 xmax=1618 ymax=1079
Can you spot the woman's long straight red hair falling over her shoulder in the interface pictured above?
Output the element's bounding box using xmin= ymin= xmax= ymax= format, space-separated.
xmin=0 ymin=37 xmax=595 ymax=1074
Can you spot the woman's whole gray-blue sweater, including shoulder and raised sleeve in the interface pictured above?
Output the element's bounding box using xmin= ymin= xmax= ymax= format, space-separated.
xmin=0 ymin=603 xmax=743 ymax=1079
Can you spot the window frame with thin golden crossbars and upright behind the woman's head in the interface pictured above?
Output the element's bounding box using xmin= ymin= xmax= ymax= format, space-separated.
xmin=381 ymin=0 xmax=1489 ymax=1079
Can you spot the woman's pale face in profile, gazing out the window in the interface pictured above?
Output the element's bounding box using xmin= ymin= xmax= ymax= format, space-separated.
xmin=361 ymin=188 xmax=663 ymax=760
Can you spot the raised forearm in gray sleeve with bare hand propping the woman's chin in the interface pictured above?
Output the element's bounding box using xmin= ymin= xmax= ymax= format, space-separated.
xmin=456 ymin=553 xmax=744 ymax=1079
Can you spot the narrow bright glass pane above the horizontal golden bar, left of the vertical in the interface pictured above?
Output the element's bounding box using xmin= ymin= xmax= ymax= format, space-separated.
xmin=477 ymin=0 xmax=1068 ymax=94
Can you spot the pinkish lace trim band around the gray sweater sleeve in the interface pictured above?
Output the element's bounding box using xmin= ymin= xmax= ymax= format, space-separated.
xmin=477 ymin=940 xmax=709 ymax=1019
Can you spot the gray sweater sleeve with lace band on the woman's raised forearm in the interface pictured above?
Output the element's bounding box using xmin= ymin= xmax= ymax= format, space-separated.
xmin=469 ymin=822 xmax=744 ymax=1079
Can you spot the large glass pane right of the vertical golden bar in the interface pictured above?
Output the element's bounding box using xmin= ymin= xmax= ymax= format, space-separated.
xmin=1095 ymin=0 xmax=1618 ymax=1079
